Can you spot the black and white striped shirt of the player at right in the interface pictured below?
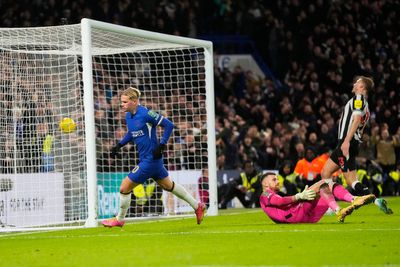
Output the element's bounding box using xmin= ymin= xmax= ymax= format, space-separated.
xmin=338 ymin=95 xmax=370 ymax=143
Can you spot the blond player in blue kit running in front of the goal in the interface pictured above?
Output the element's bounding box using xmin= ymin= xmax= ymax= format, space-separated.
xmin=101 ymin=87 xmax=206 ymax=227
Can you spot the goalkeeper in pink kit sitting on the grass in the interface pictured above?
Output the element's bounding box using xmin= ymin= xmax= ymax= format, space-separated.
xmin=260 ymin=172 xmax=375 ymax=223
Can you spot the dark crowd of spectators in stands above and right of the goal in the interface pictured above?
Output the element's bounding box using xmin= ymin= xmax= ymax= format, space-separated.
xmin=0 ymin=0 xmax=400 ymax=197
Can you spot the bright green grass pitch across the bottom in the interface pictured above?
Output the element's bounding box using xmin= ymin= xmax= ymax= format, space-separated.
xmin=0 ymin=198 xmax=400 ymax=267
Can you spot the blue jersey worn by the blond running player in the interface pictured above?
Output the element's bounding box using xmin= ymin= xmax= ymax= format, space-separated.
xmin=119 ymin=105 xmax=174 ymax=161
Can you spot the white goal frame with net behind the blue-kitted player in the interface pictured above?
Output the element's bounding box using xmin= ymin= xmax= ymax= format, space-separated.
xmin=0 ymin=19 xmax=218 ymax=232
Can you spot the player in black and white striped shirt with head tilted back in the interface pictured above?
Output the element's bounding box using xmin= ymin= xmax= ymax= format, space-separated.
xmin=321 ymin=76 xmax=393 ymax=214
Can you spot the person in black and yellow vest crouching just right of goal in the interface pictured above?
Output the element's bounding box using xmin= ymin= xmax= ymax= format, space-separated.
xmin=218 ymin=161 xmax=261 ymax=209
